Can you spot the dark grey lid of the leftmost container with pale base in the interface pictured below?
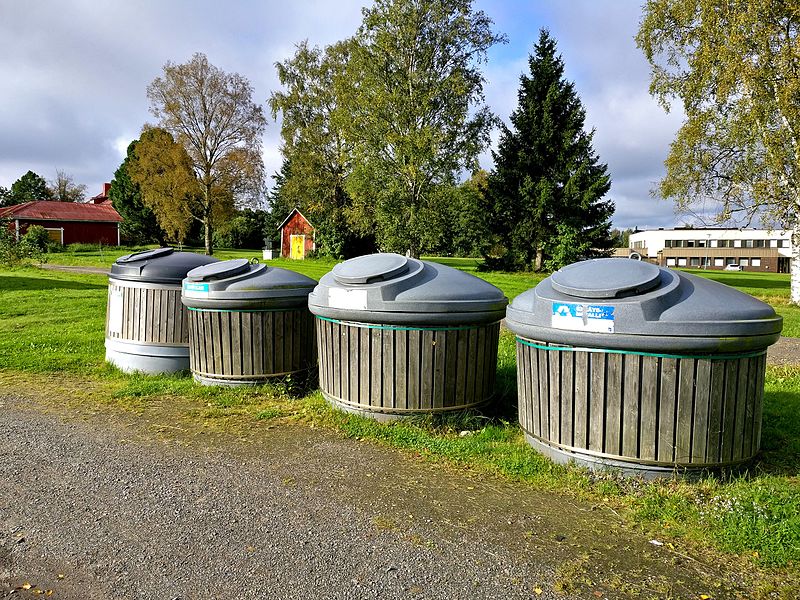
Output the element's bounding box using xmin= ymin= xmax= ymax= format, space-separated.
xmin=109 ymin=248 xmax=219 ymax=285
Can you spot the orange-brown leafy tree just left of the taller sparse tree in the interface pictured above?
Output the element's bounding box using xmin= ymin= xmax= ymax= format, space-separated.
xmin=128 ymin=127 xmax=199 ymax=243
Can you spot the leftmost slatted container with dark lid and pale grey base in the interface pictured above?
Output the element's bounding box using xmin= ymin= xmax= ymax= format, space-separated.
xmin=105 ymin=248 xmax=217 ymax=374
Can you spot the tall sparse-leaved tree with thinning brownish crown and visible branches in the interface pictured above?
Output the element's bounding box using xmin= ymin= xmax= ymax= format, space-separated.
xmin=145 ymin=53 xmax=266 ymax=254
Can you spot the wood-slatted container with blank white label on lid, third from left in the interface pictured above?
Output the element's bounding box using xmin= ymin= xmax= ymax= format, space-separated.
xmin=308 ymin=254 xmax=508 ymax=420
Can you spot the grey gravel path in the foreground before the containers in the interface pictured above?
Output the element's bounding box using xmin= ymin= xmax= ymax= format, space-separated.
xmin=0 ymin=394 xmax=740 ymax=600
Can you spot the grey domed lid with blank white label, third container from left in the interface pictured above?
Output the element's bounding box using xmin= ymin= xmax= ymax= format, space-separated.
xmin=308 ymin=253 xmax=508 ymax=327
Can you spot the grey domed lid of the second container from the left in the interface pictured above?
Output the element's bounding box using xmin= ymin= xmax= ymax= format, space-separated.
xmin=181 ymin=258 xmax=317 ymax=310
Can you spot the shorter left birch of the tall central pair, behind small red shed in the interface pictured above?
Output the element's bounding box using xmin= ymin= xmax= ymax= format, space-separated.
xmin=269 ymin=40 xmax=374 ymax=258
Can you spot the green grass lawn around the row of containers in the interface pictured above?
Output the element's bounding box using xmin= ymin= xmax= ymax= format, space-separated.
xmin=0 ymin=266 xmax=800 ymax=584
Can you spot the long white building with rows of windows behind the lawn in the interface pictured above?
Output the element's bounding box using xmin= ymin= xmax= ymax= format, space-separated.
xmin=629 ymin=227 xmax=792 ymax=273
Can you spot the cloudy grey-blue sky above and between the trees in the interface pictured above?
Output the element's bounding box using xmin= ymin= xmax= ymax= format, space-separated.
xmin=0 ymin=0 xmax=682 ymax=229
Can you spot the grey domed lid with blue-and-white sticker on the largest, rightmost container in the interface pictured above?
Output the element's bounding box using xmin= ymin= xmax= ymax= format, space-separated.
xmin=506 ymin=258 xmax=783 ymax=354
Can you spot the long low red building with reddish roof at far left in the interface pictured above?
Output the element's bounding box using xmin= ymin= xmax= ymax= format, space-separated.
xmin=0 ymin=199 xmax=122 ymax=246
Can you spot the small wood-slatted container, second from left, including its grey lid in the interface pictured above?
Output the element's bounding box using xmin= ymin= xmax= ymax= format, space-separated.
xmin=181 ymin=258 xmax=317 ymax=385
